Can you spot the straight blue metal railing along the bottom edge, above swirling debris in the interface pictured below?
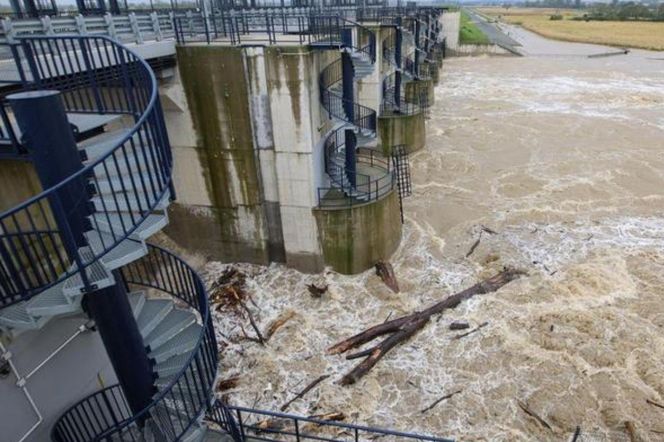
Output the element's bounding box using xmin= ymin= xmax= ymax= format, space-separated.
xmin=207 ymin=401 xmax=453 ymax=442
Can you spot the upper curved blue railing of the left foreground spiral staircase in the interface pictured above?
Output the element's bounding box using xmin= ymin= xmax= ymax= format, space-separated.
xmin=0 ymin=36 xmax=173 ymax=308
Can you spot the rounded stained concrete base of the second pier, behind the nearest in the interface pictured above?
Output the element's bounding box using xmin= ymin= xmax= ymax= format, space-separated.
xmin=378 ymin=111 xmax=426 ymax=156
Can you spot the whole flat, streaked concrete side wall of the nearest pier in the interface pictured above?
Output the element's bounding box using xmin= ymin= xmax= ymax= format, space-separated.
xmin=167 ymin=45 xmax=339 ymax=271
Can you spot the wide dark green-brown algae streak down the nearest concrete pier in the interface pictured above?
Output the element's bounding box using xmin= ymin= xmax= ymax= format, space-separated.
xmin=177 ymin=46 xmax=264 ymax=260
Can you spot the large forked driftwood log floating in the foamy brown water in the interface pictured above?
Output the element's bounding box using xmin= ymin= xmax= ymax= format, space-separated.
xmin=327 ymin=269 xmax=525 ymax=385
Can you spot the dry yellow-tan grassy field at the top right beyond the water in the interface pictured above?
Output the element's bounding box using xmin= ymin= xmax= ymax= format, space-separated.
xmin=479 ymin=7 xmax=664 ymax=50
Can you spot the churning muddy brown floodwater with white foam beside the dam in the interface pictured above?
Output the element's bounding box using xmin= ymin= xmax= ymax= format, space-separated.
xmin=207 ymin=35 xmax=664 ymax=441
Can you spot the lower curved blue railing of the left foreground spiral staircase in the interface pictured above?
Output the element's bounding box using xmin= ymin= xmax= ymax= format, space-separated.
xmin=51 ymin=245 xmax=219 ymax=442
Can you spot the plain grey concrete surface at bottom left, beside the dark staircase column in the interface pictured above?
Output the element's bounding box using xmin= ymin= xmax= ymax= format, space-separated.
xmin=0 ymin=315 xmax=117 ymax=442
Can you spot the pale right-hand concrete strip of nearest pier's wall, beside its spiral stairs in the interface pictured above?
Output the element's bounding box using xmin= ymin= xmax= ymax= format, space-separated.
xmin=264 ymin=46 xmax=325 ymax=272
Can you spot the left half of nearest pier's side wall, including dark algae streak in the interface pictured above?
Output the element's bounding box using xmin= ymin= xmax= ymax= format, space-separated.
xmin=166 ymin=46 xmax=268 ymax=262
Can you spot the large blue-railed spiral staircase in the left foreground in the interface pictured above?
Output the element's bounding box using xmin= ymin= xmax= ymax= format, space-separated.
xmin=0 ymin=36 xmax=220 ymax=442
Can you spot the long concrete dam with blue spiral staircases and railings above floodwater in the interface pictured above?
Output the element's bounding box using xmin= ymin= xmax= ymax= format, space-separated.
xmin=0 ymin=0 xmax=446 ymax=442
